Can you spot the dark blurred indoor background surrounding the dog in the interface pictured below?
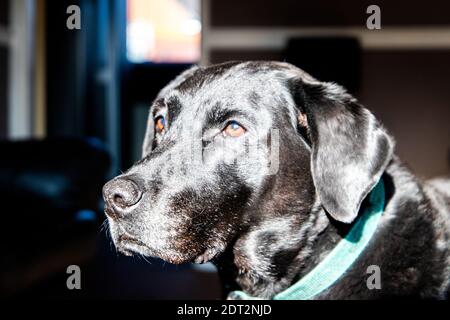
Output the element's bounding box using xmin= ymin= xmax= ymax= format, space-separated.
xmin=0 ymin=0 xmax=450 ymax=299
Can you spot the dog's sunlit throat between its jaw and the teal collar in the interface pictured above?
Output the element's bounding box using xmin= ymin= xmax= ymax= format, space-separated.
xmin=217 ymin=206 xmax=348 ymax=298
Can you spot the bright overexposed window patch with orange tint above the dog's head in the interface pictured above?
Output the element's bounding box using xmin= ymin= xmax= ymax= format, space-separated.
xmin=127 ymin=0 xmax=201 ymax=63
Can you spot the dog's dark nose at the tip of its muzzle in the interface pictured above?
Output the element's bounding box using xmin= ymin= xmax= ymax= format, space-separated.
xmin=103 ymin=178 xmax=142 ymax=214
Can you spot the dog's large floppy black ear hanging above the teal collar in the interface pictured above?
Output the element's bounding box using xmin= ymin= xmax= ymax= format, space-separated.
xmin=292 ymin=78 xmax=394 ymax=223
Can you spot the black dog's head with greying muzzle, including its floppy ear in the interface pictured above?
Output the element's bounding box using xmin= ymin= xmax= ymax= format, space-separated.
xmin=104 ymin=62 xmax=392 ymax=263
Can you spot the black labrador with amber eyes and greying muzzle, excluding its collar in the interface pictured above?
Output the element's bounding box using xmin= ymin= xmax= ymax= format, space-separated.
xmin=103 ymin=61 xmax=450 ymax=299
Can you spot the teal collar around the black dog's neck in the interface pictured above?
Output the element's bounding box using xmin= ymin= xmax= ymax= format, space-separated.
xmin=232 ymin=179 xmax=385 ymax=300
